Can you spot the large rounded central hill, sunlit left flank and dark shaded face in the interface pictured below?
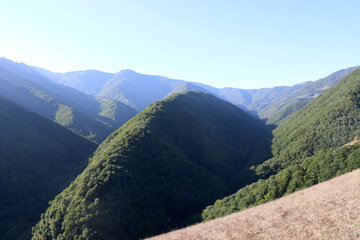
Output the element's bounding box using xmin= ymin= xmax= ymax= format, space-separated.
xmin=32 ymin=92 xmax=270 ymax=239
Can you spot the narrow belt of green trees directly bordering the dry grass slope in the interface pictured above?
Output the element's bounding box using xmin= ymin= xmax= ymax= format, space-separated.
xmin=202 ymin=145 xmax=360 ymax=221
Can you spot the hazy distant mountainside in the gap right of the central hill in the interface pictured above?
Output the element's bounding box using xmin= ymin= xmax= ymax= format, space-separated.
xmin=199 ymin=67 xmax=358 ymax=124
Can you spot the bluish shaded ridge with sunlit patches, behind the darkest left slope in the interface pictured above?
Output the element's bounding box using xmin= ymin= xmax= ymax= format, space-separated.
xmin=0 ymin=58 xmax=137 ymax=143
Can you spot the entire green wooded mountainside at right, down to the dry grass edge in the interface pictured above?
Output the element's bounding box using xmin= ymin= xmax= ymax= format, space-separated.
xmin=195 ymin=69 xmax=360 ymax=220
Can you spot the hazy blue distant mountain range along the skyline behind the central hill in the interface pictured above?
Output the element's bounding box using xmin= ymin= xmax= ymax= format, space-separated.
xmin=0 ymin=58 xmax=357 ymax=125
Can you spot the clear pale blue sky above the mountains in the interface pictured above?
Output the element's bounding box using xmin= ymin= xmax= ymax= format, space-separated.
xmin=0 ymin=0 xmax=360 ymax=88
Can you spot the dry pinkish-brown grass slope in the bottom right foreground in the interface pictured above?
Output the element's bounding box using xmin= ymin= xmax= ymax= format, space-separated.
xmin=146 ymin=169 xmax=360 ymax=240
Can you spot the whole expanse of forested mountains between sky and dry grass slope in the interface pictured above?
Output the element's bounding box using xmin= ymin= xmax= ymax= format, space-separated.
xmin=0 ymin=58 xmax=360 ymax=240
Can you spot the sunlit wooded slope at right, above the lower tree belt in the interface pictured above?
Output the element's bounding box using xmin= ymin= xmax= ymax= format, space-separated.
xmin=256 ymin=69 xmax=360 ymax=178
